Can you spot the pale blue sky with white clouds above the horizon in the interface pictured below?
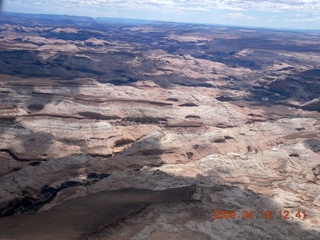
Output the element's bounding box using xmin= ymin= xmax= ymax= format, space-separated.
xmin=3 ymin=0 xmax=320 ymax=30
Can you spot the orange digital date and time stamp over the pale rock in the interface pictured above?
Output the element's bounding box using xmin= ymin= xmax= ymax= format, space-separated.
xmin=211 ymin=209 xmax=307 ymax=220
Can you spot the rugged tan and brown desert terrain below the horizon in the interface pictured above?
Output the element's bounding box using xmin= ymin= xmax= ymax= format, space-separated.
xmin=0 ymin=13 xmax=320 ymax=240
